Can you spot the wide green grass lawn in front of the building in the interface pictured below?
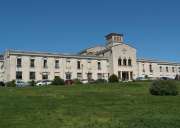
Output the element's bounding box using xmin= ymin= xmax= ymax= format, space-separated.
xmin=0 ymin=82 xmax=180 ymax=128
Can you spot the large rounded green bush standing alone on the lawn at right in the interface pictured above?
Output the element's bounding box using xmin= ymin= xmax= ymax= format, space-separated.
xmin=149 ymin=80 xmax=178 ymax=96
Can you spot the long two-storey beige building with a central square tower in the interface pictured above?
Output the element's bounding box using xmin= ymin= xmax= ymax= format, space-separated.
xmin=0 ymin=33 xmax=180 ymax=82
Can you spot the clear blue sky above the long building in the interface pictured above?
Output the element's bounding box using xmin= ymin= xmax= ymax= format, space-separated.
xmin=0 ymin=0 xmax=180 ymax=61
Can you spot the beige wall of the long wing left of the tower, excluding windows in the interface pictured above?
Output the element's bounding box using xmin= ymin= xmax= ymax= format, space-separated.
xmin=6 ymin=54 xmax=108 ymax=81
